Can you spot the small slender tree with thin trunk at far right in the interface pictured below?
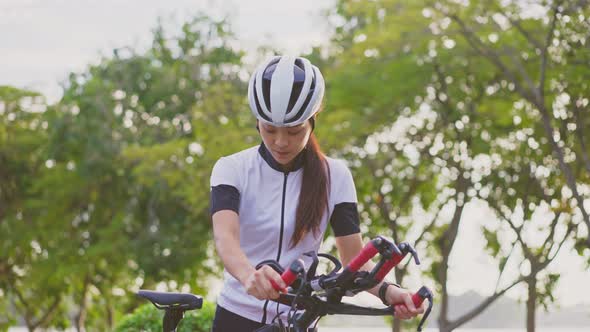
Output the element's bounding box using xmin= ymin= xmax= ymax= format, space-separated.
xmin=478 ymin=94 xmax=577 ymax=332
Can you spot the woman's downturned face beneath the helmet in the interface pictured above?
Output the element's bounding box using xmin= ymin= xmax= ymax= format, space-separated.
xmin=258 ymin=120 xmax=311 ymax=166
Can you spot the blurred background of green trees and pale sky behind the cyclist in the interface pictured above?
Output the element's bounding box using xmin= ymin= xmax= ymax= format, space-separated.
xmin=0 ymin=0 xmax=590 ymax=332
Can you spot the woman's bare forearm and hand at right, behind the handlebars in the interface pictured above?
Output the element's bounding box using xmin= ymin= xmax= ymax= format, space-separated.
xmin=336 ymin=233 xmax=424 ymax=319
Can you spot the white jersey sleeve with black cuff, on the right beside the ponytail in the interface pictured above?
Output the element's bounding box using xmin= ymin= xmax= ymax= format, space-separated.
xmin=330 ymin=161 xmax=360 ymax=236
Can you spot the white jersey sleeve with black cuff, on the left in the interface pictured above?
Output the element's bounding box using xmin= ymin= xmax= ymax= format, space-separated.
xmin=209 ymin=158 xmax=240 ymax=215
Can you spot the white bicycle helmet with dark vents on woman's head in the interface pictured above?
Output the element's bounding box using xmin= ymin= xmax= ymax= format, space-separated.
xmin=248 ymin=56 xmax=325 ymax=127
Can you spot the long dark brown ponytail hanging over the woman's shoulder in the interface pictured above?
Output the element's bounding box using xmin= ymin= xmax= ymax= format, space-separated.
xmin=291 ymin=132 xmax=330 ymax=248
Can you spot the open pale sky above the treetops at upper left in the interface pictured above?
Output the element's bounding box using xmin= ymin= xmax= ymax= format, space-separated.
xmin=0 ymin=0 xmax=333 ymax=102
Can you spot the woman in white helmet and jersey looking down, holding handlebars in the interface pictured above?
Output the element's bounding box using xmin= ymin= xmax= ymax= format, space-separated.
xmin=211 ymin=56 xmax=423 ymax=332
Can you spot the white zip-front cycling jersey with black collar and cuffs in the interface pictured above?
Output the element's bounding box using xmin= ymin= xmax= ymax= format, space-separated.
xmin=210 ymin=144 xmax=359 ymax=323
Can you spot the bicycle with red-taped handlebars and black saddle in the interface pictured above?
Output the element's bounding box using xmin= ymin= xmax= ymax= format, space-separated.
xmin=138 ymin=237 xmax=433 ymax=332
